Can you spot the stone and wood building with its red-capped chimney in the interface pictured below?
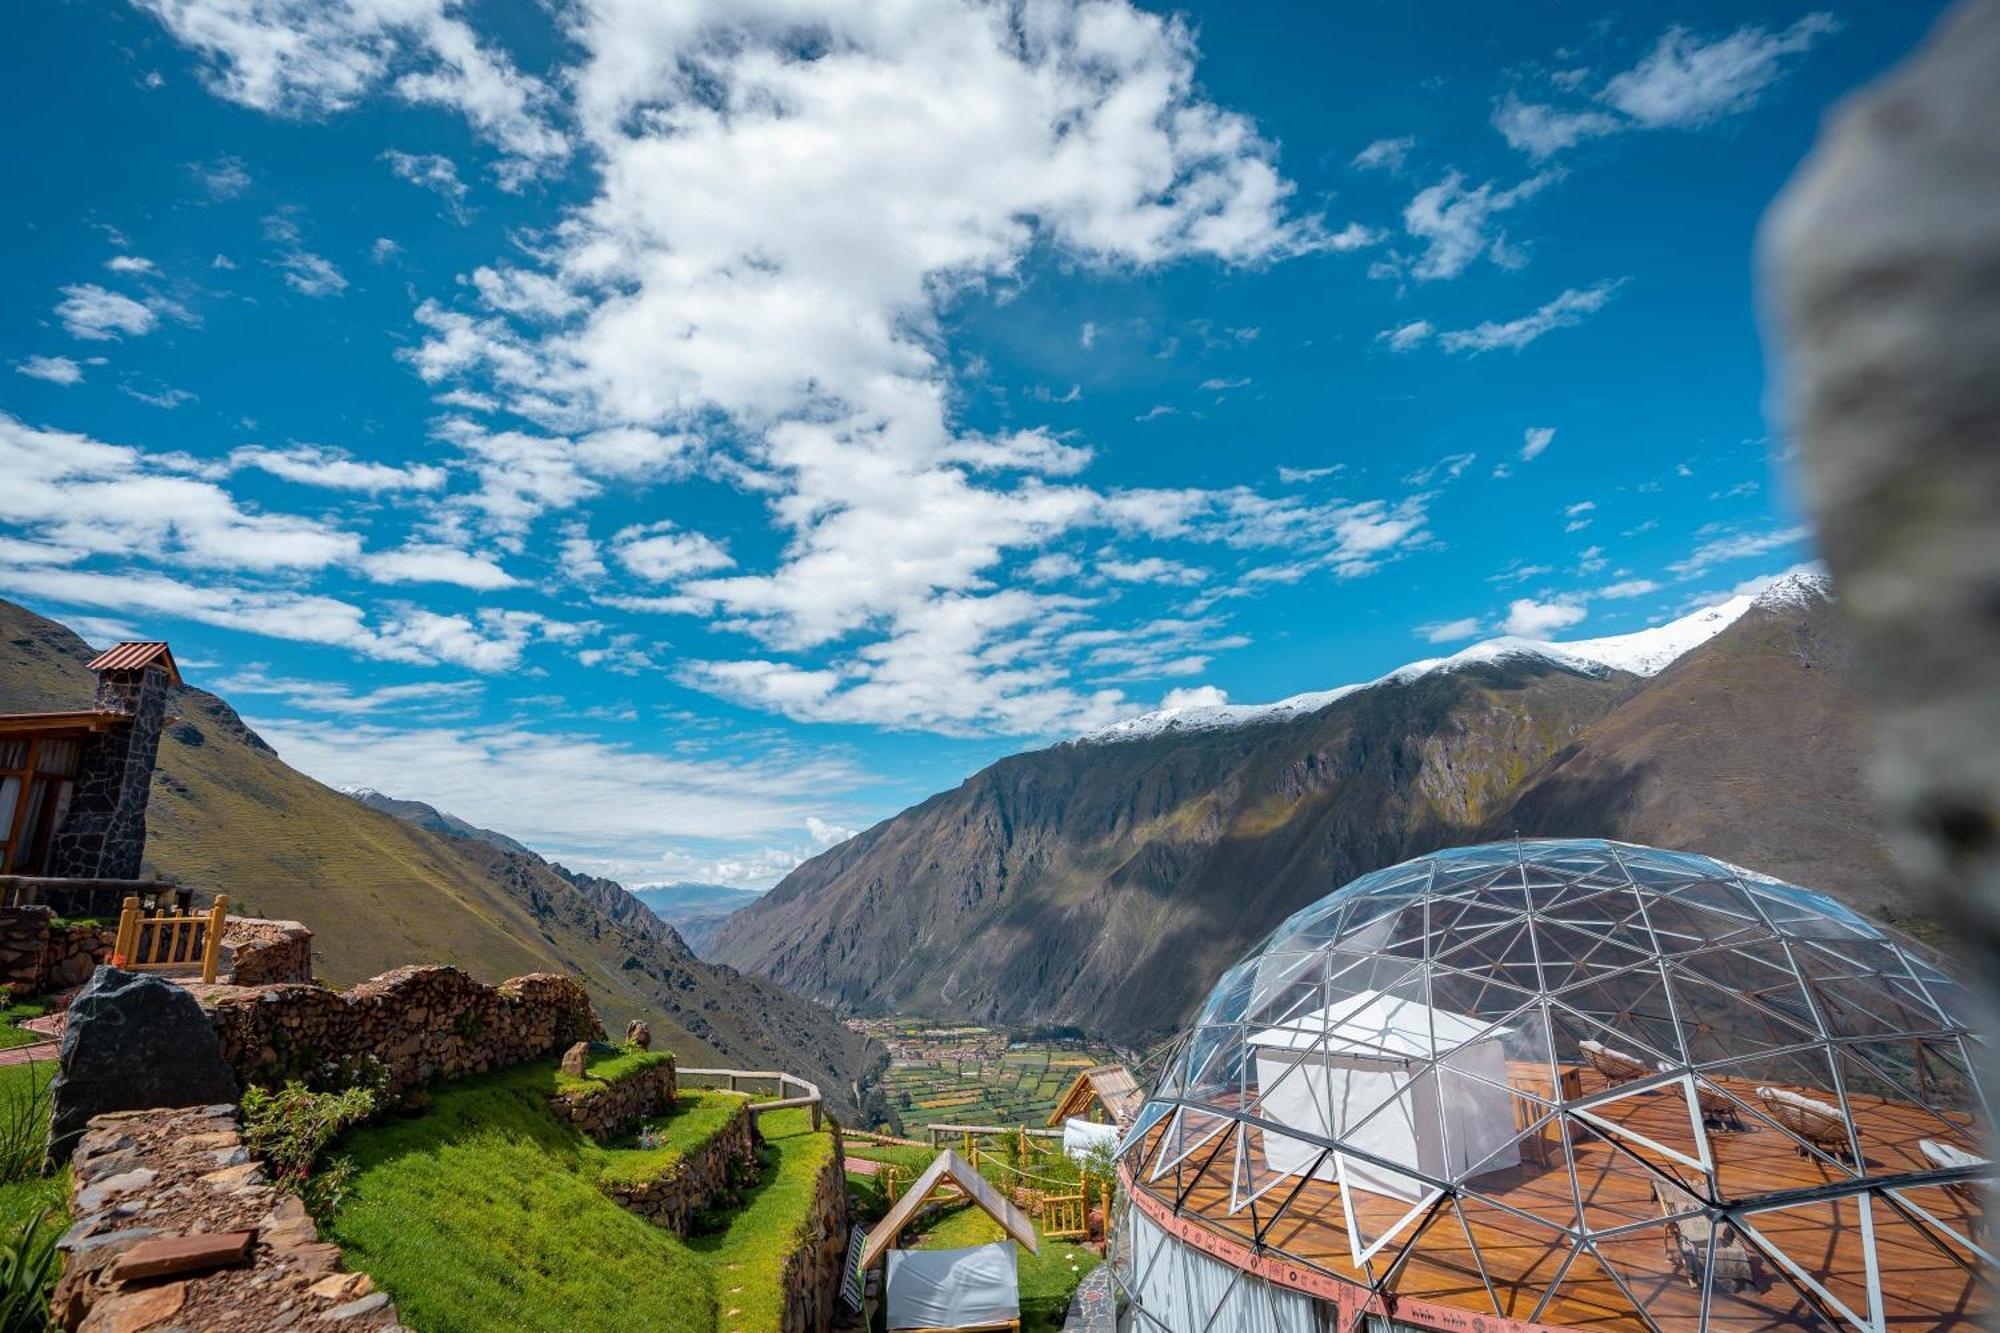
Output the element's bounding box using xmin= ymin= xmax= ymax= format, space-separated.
xmin=0 ymin=642 xmax=180 ymax=879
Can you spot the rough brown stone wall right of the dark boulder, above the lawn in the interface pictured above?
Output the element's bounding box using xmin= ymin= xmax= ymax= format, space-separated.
xmin=208 ymin=967 xmax=604 ymax=1097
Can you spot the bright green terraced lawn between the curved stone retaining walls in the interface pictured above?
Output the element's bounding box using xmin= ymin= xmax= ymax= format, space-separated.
xmin=330 ymin=1063 xmax=832 ymax=1333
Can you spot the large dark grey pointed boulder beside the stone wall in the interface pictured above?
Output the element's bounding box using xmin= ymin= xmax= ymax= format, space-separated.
xmin=48 ymin=967 xmax=238 ymax=1163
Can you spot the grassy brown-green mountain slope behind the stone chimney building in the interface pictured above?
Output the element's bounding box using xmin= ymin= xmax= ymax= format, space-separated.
xmin=0 ymin=600 xmax=870 ymax=1105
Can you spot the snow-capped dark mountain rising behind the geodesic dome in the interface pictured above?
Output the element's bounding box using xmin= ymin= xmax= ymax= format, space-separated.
xmin=714 ymin=580 xmax=1894 ymax=1039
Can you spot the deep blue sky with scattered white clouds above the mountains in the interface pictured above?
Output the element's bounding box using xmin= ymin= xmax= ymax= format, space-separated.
xmin=0 ymin=0 xmax=1936 ymax=885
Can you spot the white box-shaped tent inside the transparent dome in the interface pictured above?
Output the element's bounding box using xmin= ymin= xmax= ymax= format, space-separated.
xmin=1248 ymin=991 xmax=1520 ymax=1201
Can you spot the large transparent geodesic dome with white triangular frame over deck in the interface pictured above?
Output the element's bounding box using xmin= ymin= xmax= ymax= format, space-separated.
xmin=1112 ymin=841 xmax=1992 ymax=1333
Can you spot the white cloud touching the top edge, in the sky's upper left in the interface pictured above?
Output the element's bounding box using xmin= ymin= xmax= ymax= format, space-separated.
xmin=136 ymin=0 xmax=570 ymax=180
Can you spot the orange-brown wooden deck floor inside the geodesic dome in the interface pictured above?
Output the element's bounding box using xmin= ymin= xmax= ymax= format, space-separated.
xmin=1148 ymin=1071 xmax=1988 ymax=1333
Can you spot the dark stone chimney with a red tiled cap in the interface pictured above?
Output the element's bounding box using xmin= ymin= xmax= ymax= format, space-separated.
xmin=48 ymin=642 xmax=180 ymax=879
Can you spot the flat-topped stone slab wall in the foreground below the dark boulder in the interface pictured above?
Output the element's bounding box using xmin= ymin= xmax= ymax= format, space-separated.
xmin=54 ymin=1107 xmax=400 ymax=1333
